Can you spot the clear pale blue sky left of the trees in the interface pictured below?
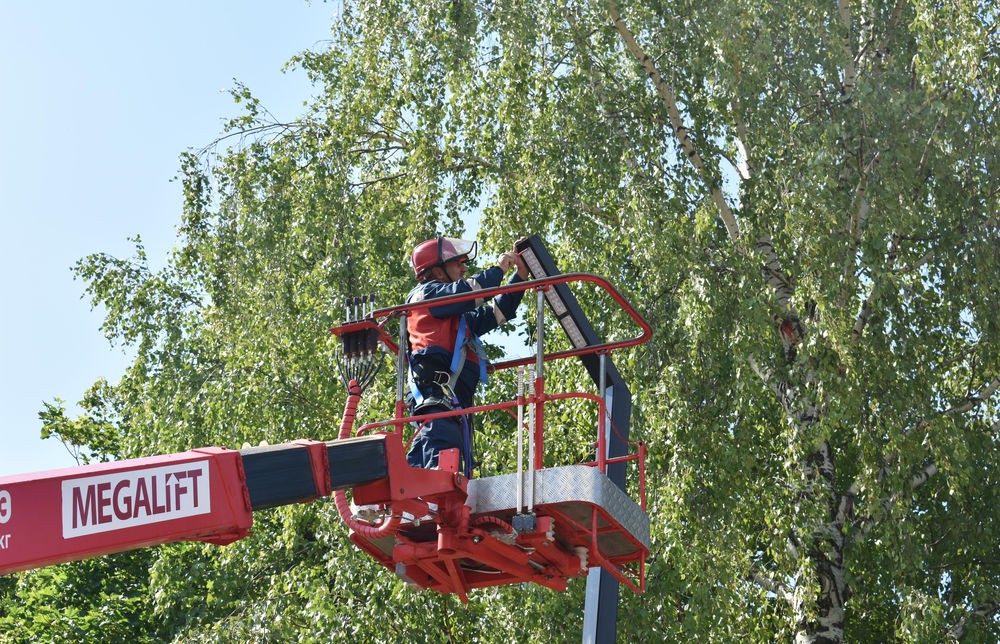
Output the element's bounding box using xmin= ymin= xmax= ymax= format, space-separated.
xmin=0 ymin=0 xmax=337 ymax=476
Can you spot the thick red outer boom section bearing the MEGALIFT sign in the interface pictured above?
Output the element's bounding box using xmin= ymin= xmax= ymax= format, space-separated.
xmin=0 ymin=447 xmax=252 ymax=574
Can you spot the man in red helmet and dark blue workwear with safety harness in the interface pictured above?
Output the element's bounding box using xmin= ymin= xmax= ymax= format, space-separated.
xmin=406 ymin=237 xmax=528 ymax=475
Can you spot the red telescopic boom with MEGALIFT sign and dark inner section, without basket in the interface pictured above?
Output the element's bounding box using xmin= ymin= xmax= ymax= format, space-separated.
xmin=0 ymin=436 xmax=387 ymax=575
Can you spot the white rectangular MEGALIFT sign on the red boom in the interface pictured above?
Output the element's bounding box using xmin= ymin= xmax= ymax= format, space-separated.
xmin=62 ymin=461 xmax=212 ymax=539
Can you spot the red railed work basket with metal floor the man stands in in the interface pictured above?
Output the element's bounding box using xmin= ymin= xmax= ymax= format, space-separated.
xmin=332 ymin=236 xmax=651 ymax=601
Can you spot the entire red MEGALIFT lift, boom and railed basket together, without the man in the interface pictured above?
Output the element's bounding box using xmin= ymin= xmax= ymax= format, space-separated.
xmin=0 ymin=236 xmax=651 ymax=620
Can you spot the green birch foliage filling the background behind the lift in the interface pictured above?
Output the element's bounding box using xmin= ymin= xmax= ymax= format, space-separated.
xmin=9 ymin=0 xmax=1000 ymax=641
